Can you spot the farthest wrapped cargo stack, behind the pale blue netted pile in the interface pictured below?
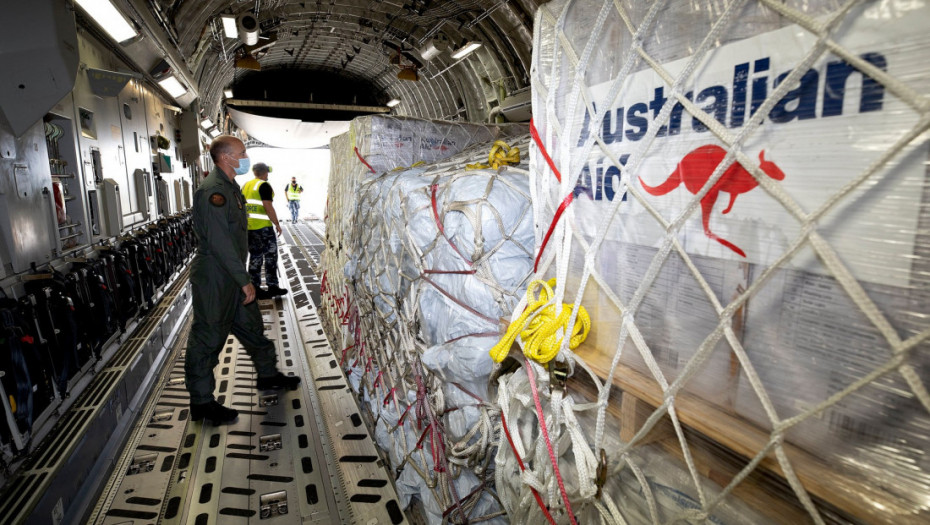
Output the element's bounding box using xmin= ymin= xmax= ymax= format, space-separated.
xmin=321 ymin=115 xmax=525 ymax=344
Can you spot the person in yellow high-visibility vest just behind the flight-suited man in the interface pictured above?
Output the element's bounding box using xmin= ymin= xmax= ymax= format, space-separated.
xmin=242 ymin=162 xmax=287 ymax=299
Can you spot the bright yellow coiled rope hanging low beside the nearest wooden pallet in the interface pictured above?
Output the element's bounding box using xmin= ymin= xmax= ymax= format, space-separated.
xmin=490 ymin=279 xmax=591 ymax=364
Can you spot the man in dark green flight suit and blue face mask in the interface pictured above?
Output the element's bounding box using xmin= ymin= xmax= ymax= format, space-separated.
xmin=184 ymin=135 xmax=300 ymax=424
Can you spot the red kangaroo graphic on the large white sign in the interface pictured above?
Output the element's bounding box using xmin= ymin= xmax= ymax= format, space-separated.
xmin=639 ymin=144 xmax=785 ymax=257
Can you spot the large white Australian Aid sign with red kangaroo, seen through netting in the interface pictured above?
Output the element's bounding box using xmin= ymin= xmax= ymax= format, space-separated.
xmin=560 ymin=5 xmax=930 ymax=286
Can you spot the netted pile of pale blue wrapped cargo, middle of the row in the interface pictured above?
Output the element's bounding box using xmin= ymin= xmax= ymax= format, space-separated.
xmin=327 ymin=126 xmax=534 ymax=523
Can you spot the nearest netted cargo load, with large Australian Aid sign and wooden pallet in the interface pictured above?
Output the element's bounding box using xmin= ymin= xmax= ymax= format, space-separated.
xmin=496 ymin=0 xmax=930 ymax=524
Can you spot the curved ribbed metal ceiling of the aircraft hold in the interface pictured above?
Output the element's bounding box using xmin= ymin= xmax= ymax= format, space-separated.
xmin=115 ymin=0 xmax=541 ymax=127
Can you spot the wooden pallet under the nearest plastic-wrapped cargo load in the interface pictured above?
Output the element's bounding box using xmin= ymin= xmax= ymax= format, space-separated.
xmin=568 ymin=351 xmax=930 ymax=524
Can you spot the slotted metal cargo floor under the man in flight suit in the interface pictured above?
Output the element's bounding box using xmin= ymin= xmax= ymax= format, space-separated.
xmin=88 ymin=223 xmax=406 ymax=525
